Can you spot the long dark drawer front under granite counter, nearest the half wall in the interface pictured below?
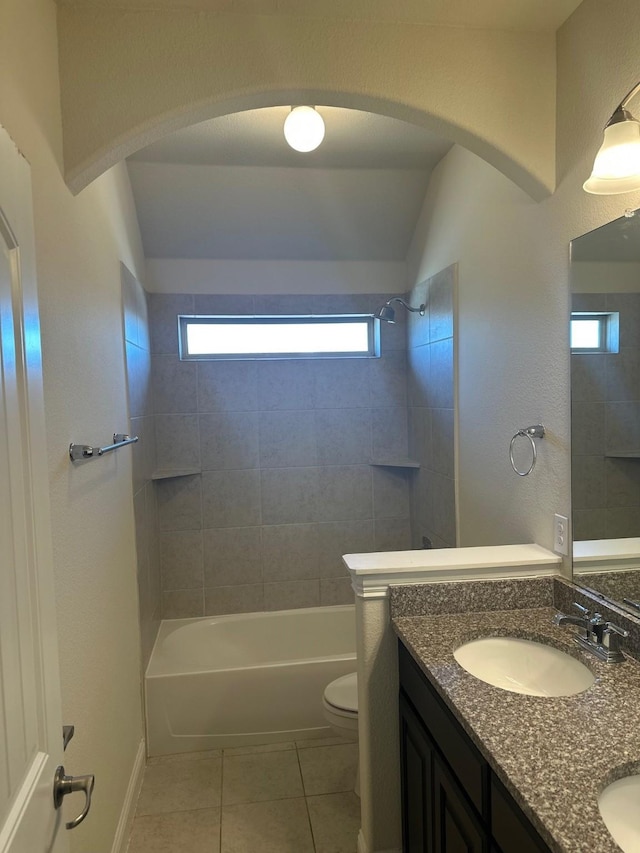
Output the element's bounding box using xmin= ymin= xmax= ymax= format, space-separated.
xmin=398 ymin=643 xmax=489 ymax=820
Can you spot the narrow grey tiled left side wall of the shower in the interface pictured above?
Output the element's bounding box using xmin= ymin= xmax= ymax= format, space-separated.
xmin=121 ymin=264 xmax=161 ymax=670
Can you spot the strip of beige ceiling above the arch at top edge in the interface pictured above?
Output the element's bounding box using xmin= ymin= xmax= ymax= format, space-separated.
xmin=57 ymin=0 xmax=581 ymax=32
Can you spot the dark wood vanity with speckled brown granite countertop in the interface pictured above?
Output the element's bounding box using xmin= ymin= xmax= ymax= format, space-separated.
xmin=391 ymin=578 xmax=640 ymax=853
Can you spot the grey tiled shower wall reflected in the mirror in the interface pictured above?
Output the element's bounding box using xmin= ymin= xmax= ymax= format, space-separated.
xmin=571 ymin=293 xmax=640 ymax=540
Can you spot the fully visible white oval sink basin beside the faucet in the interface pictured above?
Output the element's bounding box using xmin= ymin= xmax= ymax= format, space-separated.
xmin=453 ymin=637 xmax=595 ymax=696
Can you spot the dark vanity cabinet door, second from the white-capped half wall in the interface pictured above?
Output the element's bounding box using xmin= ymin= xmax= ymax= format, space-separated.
xmin=433 ymin=757 xmax=488 ymax=853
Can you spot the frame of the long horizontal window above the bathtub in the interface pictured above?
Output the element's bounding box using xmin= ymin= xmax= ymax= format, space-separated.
xmin=178 ymin=313 xmax=380 ymax=361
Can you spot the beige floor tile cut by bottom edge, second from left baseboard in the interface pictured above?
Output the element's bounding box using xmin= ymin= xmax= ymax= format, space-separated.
xmin=221 ymin=797 xmax=314 ymax=853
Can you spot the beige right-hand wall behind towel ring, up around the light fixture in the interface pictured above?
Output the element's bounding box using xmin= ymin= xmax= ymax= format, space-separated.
xmin=407 ymin=0 xmax=640 ymax=560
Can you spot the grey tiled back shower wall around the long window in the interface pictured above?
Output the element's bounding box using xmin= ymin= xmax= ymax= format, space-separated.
xmin=149 ymin=294 xmax=414 ymax=618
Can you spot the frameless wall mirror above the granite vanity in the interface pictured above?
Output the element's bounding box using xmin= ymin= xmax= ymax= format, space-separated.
xmin=570 ymin=210 xmax=640 ymax=616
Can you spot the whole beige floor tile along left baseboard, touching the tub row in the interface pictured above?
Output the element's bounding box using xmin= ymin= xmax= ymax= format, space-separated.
xmin=136 ymin=758 xmax=222 ymax=815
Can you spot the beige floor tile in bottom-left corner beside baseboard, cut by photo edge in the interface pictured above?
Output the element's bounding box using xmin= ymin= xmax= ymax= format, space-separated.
xmin=127 ymin=809 xmax=220 ymax=853
